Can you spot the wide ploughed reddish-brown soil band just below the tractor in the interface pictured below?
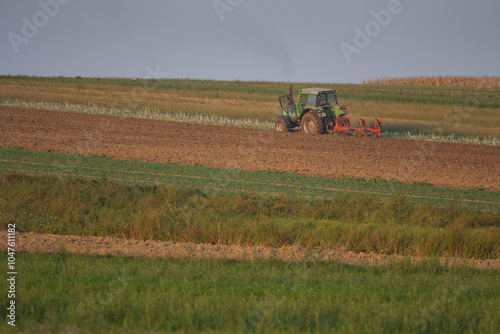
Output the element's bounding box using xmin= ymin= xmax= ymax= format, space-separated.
xmin=0 ymin=107 xmax=500 ymax=190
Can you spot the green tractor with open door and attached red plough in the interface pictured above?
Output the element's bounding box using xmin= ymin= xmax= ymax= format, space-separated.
xmin=275 ymin=86 xmax=382 ymax=137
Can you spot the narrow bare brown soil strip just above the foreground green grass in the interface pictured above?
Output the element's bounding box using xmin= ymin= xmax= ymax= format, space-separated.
xmin=0 ymin=231 xmax=500 ymax=270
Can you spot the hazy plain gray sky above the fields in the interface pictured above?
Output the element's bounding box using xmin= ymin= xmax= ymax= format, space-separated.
xmin=0 ymin=0 xmax=500 ymax=83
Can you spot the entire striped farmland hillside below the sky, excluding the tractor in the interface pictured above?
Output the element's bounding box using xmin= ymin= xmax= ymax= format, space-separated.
xmin=0 ymin=76 xmax=500 ymax=333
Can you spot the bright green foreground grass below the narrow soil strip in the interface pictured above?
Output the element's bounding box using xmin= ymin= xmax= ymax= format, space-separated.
xmin=0 ymin=253 xmax=500 ymax=333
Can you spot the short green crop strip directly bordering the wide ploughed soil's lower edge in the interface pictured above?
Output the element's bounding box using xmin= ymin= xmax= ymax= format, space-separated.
xmin=0 ymin=148 xmax=500 ymax=212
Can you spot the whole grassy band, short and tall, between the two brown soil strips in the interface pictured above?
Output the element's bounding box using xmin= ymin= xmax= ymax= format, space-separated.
xmin=0 ymin=149 xmax=500 ymax=259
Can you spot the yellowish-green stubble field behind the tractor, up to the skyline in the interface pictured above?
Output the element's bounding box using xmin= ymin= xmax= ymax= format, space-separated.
xmin=0 ymin=76 xmax=500 ymax=137
